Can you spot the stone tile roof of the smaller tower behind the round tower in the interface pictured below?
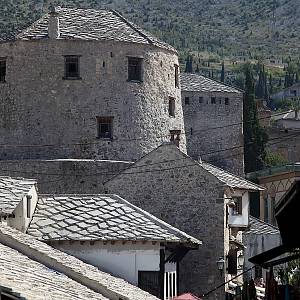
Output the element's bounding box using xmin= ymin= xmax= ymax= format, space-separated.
xmin=180 ymin=73 xmax=242 ymax=94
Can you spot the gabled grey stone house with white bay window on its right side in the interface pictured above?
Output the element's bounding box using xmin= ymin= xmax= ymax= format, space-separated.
xmin=104 ymin=143 xmax=262 ymax=299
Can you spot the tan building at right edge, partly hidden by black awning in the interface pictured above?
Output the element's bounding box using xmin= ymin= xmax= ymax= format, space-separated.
xmin=247 ymin=163 xmax=300 ymax=225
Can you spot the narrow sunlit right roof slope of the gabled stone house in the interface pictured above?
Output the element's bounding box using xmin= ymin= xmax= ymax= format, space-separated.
xmin=201 ymin=162 xmax=264 ymax=191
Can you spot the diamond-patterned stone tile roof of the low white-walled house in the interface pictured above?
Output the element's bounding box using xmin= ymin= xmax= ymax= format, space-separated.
xmin=28 ymin=195 xmax=201 ymax=244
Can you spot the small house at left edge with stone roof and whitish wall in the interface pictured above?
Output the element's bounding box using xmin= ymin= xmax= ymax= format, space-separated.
xmin=0 ymin=176 xmax=38 ymax=231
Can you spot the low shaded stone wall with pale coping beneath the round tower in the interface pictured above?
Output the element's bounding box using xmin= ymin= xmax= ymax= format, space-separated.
xmin=0 ymin=159 xmax=131 ymax=194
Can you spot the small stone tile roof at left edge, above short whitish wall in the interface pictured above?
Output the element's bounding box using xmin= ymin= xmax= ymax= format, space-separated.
xmin=0 ymin=176 xmax=36 ymax=215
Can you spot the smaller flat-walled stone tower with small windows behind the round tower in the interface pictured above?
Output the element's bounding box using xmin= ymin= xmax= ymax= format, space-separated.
xmin=180 ymin=73 xmax=244 ymax=175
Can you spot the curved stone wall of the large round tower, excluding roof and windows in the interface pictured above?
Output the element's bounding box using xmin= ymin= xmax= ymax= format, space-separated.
xmin=0 ymin=39 xmax=185 ymax=161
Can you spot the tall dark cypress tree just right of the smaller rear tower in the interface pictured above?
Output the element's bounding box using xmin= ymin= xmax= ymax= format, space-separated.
xmin=243 ymin=63 xmax=268 ymax=173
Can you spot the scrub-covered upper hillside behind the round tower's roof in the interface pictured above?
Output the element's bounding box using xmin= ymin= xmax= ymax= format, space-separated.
xmin=0 ymin=0 xmax=300 ymax=58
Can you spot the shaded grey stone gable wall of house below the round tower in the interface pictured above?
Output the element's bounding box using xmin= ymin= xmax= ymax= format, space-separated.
xmin=105 ymin=145 xmax=225 ymax=300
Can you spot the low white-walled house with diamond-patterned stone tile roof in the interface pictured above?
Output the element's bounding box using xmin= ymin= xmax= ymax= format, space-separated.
xmin=27 ymin=195 xmax=201 ymax=300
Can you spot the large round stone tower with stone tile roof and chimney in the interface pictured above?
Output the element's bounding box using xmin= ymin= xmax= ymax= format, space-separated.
xmin=0 ymin=7 xmax=185 ymax=160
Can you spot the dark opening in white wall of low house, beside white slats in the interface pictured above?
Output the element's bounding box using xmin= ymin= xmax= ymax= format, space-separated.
xmin=138 ymin=271 xmax=160 ymax=297
